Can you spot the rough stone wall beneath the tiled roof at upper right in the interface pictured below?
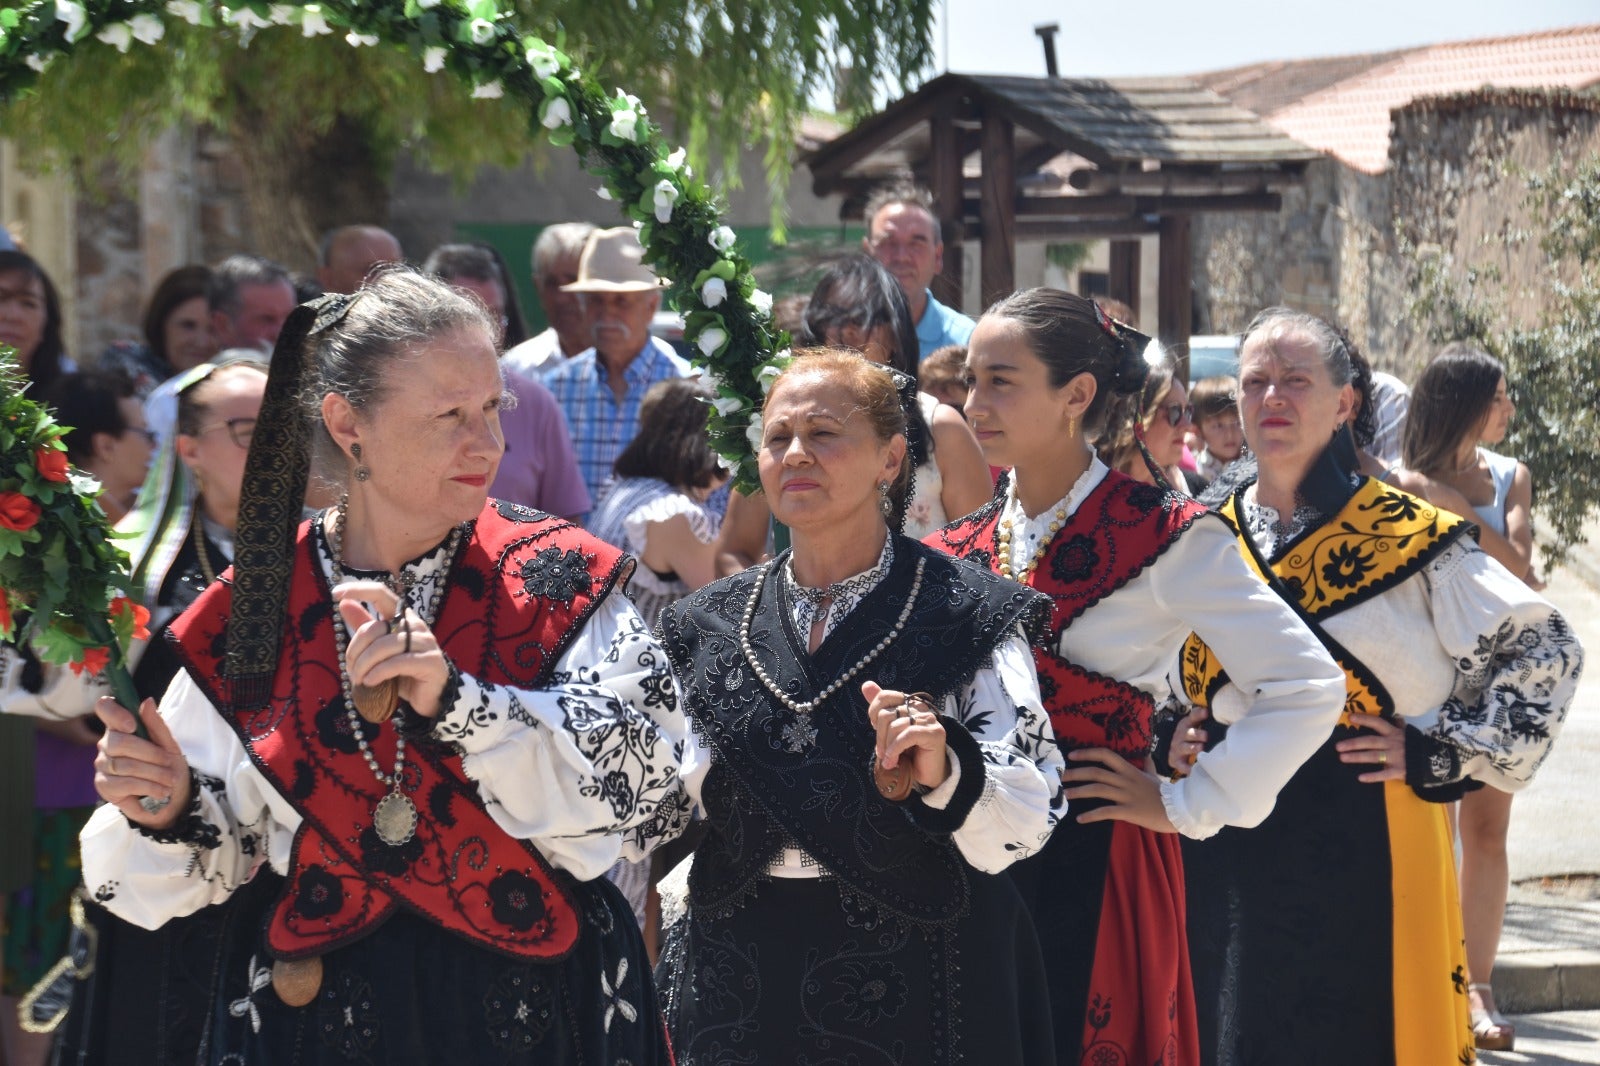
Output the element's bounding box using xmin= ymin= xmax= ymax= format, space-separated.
xmin=1194 ymin=90 xmax=1600 ymax=379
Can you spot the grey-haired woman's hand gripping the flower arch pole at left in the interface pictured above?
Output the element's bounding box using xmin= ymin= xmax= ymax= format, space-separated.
xmin=94 ymin=696 xmax=190 ymax=829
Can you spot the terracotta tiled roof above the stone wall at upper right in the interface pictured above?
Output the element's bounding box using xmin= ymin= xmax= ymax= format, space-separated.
xmin=1269 ymin=24 xmax=1600 ymax=174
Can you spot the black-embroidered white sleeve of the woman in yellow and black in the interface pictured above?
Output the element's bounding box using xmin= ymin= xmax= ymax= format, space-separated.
xmin=1406 ymin=541 xmax=1584 ymax=792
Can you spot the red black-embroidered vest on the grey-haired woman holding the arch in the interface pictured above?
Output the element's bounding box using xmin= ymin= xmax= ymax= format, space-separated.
xmin=171 ymin=499 xmax=627 ymax=959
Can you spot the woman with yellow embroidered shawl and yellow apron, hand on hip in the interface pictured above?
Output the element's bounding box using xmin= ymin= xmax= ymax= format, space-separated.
xmin=1182 ymin=307 xmax=1582 ymax=1066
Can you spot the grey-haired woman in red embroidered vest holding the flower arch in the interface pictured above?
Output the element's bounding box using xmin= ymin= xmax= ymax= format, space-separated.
xmin=83 ymin=267 xmax=686 ymax=1064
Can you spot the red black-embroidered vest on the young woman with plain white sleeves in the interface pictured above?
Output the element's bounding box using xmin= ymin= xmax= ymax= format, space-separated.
xmin=926 ymin=471 xmax=1208 ymax=762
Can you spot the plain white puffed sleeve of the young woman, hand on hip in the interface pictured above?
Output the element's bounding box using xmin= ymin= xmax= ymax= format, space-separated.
xmin=1154 ymin=520 xmax=1344 ymax=840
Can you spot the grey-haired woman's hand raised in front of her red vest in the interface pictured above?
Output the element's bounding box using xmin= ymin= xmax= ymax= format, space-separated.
xmin=333 ymin=581 xmax=450 ymax=719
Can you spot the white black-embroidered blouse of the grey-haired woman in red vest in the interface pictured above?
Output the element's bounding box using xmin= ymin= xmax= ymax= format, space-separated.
xmin=82 ymin=518 xmax=688 ymax=928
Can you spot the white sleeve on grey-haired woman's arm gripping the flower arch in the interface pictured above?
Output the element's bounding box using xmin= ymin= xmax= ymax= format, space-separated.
xmin=78 ymin=671 xmax=299 ymax=928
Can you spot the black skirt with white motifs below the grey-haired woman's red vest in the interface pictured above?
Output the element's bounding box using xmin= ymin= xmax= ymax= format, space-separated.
xmin=211 ymin=877 xmax=670 ymax=1066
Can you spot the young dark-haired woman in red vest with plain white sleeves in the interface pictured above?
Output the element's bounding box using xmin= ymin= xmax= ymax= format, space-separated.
xmin=930 ymin=290 xmax=1342 ymax=1066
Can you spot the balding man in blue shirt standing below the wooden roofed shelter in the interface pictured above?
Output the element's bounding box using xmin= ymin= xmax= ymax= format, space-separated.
xmin=862 ymin=186 xmax=974 ymax=359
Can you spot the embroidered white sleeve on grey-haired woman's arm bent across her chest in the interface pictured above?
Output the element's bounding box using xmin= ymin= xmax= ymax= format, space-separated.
xmin=434 ymin=589 xmax=688 ymax=879
